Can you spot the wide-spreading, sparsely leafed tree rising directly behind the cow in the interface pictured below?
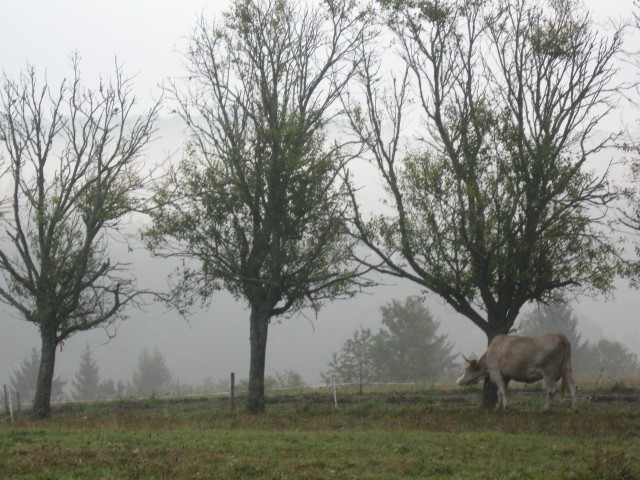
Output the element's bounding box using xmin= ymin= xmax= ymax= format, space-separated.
xmin=345 ymin=0 xmax=622 ymax=404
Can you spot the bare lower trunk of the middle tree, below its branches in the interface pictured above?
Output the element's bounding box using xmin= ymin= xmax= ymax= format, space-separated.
xmin=247 ymin=306 xmax=269 ymax=413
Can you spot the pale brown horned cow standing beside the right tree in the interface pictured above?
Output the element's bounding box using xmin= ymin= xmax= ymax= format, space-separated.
xmin=457 ymin=333 xmax=577 ymax=412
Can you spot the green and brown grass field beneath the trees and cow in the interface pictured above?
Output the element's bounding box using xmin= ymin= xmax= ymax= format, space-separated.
xmin=0 ymin=387 xmax=640 ymax=480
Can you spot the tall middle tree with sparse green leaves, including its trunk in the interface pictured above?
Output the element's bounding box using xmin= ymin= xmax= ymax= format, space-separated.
xmin=145 ymin=0 xmax=372 ymax=411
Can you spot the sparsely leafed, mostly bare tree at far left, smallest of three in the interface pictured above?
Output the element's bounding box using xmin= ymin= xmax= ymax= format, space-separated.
xmin=0 ymin=55 xmax=158 ymax=417
